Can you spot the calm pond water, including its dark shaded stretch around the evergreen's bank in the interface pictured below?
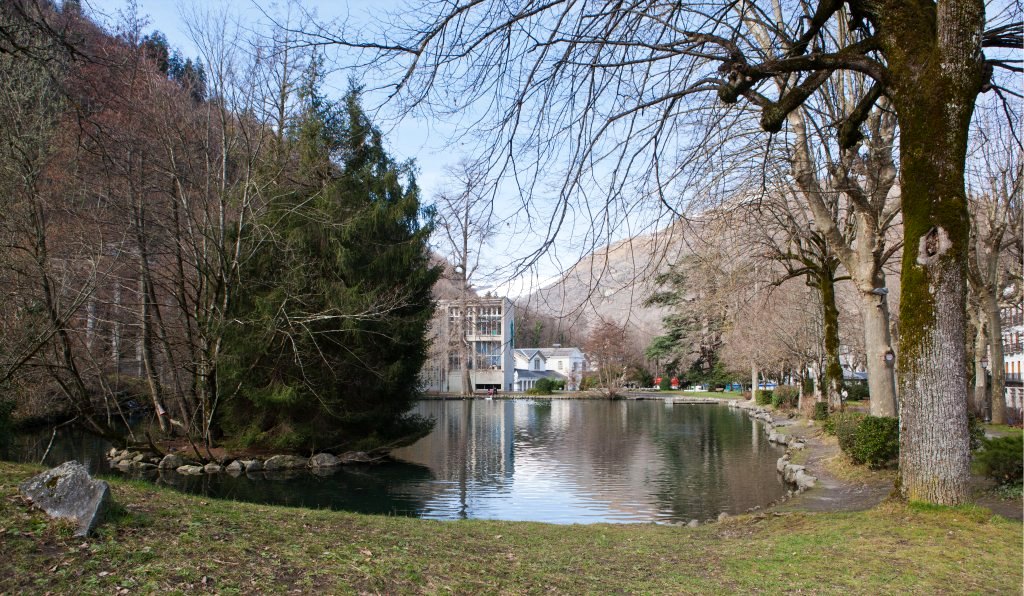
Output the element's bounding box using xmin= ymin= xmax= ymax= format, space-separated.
xmin=6 ymin=400 xmax=785 ymax=523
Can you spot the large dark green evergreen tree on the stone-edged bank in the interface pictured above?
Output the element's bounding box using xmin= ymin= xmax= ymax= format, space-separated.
xmin=220 ymin=78 xmax=439 ymax=451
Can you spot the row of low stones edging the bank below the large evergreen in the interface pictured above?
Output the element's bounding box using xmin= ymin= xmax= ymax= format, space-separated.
xmin=108 ymin=448 xmax=381 ymax=476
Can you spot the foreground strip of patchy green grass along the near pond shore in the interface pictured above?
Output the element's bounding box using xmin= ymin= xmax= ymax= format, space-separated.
xmin=0 ymin=463 xmax=1024 ymax=594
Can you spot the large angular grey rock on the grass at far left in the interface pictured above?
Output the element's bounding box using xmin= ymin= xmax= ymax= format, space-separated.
xmin=18 ymin=461 xmax=111 ymax=537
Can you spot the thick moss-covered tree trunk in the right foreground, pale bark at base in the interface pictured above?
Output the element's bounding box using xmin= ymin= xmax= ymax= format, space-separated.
xmin=880 ymin=0 xmax=985 ymax=505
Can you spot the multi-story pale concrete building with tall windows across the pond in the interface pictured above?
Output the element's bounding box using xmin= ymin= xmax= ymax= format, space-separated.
xmin=420 ymin=296 xmax=515 ymax=393
